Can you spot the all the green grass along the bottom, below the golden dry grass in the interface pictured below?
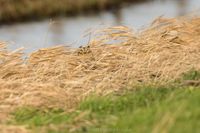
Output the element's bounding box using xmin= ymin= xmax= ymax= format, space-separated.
xmin=8 ymin=70 xmax=200 ymax=133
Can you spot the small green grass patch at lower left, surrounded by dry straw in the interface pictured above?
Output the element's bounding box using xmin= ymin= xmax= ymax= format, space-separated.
xmin=13 ymin=107 xmax=71 ymax=126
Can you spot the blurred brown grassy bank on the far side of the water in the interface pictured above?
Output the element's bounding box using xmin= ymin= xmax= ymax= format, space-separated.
xmin=0 ymin=0 xmax=146 ymax=23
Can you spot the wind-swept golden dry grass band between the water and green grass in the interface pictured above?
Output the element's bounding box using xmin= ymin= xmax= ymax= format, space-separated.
xmin=0 ymin=18 xmax=200 ymax=129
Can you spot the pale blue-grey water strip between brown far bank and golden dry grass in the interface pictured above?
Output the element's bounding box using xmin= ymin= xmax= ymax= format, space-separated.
xmin=0 ymin=0 xmax=200 ymax=53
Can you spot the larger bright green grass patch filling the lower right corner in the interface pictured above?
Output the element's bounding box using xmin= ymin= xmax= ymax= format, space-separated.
xmin=77 ymin=87 xmax=200 ymax=133
